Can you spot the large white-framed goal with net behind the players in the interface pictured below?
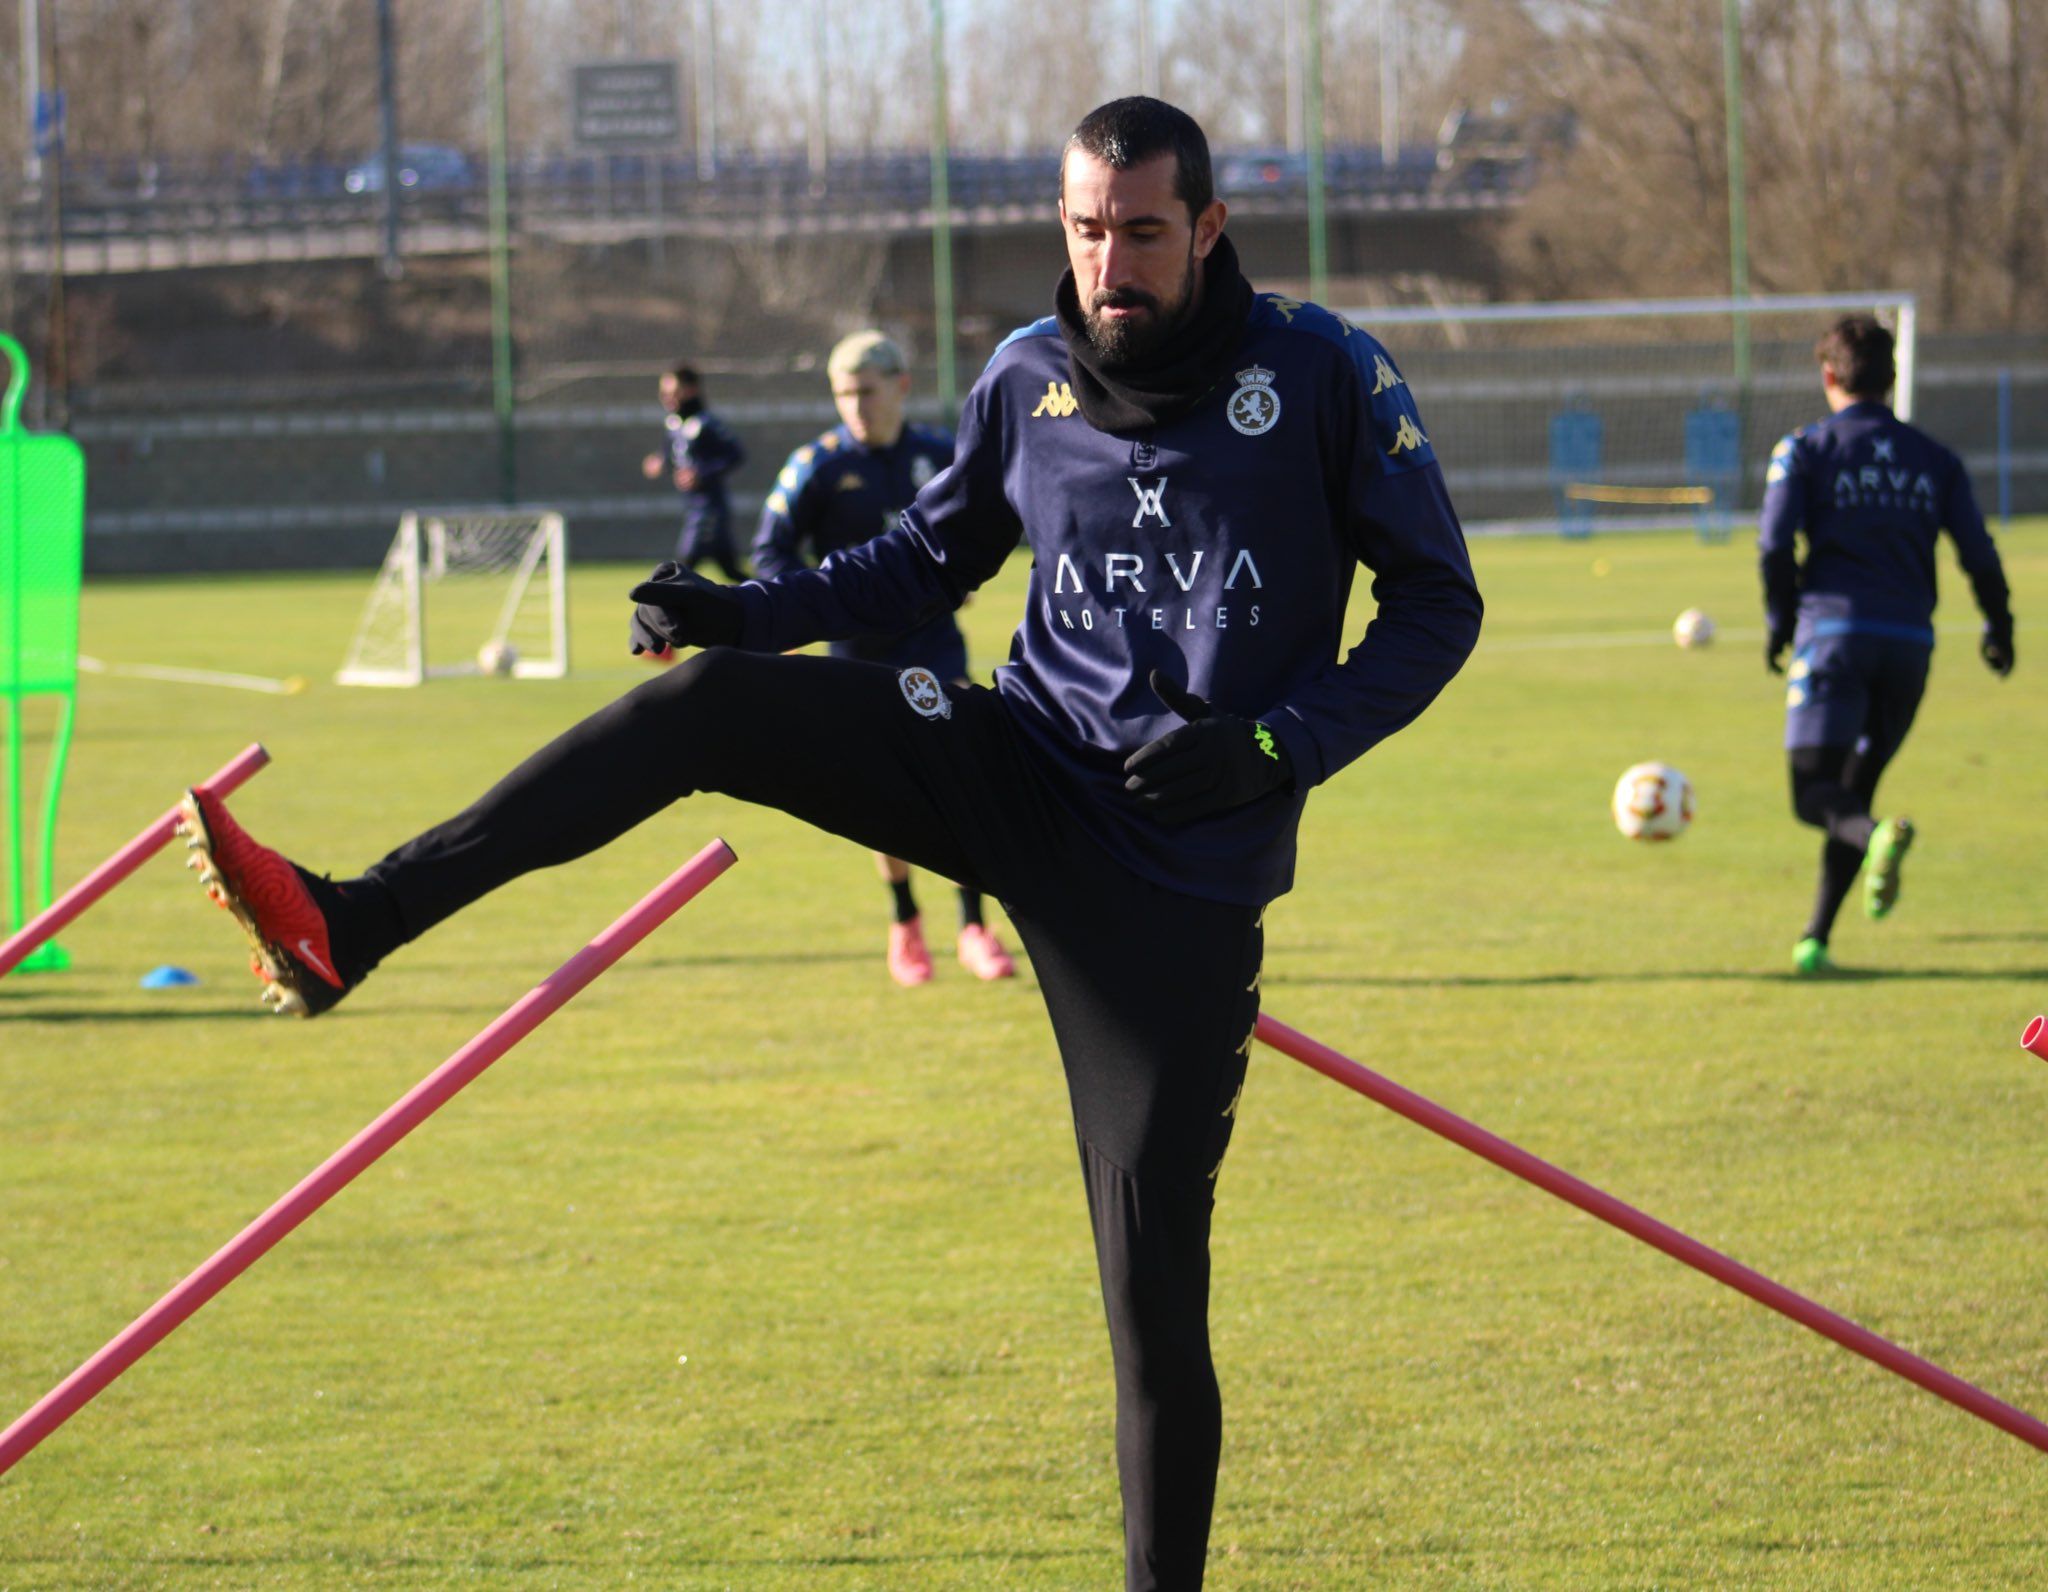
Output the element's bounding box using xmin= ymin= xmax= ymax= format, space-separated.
xmin=1343 ymin=291 xmax=1917 ymax=541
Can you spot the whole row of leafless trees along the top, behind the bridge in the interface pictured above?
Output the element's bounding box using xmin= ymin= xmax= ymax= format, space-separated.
xmin=0 ymin=0 xmax=2048 ymax=328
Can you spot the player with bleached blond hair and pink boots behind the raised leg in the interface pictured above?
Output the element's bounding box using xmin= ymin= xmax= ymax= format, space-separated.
xmin=754 ymin=330 xmax=1016 ymax=986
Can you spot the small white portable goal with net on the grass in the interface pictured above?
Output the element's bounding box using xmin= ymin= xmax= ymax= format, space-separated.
xmin=334 ymin=508 xmax=569 ymax=686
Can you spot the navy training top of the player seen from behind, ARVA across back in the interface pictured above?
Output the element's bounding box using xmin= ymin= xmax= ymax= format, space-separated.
xmin=1757 ymin=402 xmax=2007 ymax=645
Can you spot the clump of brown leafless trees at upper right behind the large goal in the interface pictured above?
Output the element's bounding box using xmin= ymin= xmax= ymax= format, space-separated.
xmin=1497 ymin=0 xmax=2048 ymax=328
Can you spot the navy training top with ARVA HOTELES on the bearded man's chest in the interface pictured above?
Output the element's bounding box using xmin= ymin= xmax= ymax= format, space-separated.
xmin=739 ymin=293 xmax=1481 ymax=904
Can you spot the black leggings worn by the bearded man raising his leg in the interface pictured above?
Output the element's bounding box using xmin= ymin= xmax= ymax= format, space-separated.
xmin=371 ymin=647 xmax=1262 ymax=1592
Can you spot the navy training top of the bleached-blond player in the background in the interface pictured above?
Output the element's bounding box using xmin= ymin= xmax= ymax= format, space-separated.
xmin=754 ymin=424 xmax=961 ymax=662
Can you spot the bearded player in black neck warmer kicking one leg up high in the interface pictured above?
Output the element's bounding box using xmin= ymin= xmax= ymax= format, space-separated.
xmin=180 ymin=98 xmax=1481 ymax=1592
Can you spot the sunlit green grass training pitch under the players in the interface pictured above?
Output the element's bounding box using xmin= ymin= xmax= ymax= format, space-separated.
xmin=0 ymin=522 xmax=2048 ymax=1592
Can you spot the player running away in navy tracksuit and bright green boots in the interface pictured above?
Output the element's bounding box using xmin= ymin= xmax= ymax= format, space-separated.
xmin=1757 ymin=316 xmax=2013 ymax=973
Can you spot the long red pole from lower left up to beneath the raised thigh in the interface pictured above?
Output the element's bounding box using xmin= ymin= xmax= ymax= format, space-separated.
xmin=0 ymin=840 xmax=737 ymax=1475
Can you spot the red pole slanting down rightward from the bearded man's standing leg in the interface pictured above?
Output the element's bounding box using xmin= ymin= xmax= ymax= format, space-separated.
xmin=1255 ymin=1014 xmax=2048 ymax=1453
